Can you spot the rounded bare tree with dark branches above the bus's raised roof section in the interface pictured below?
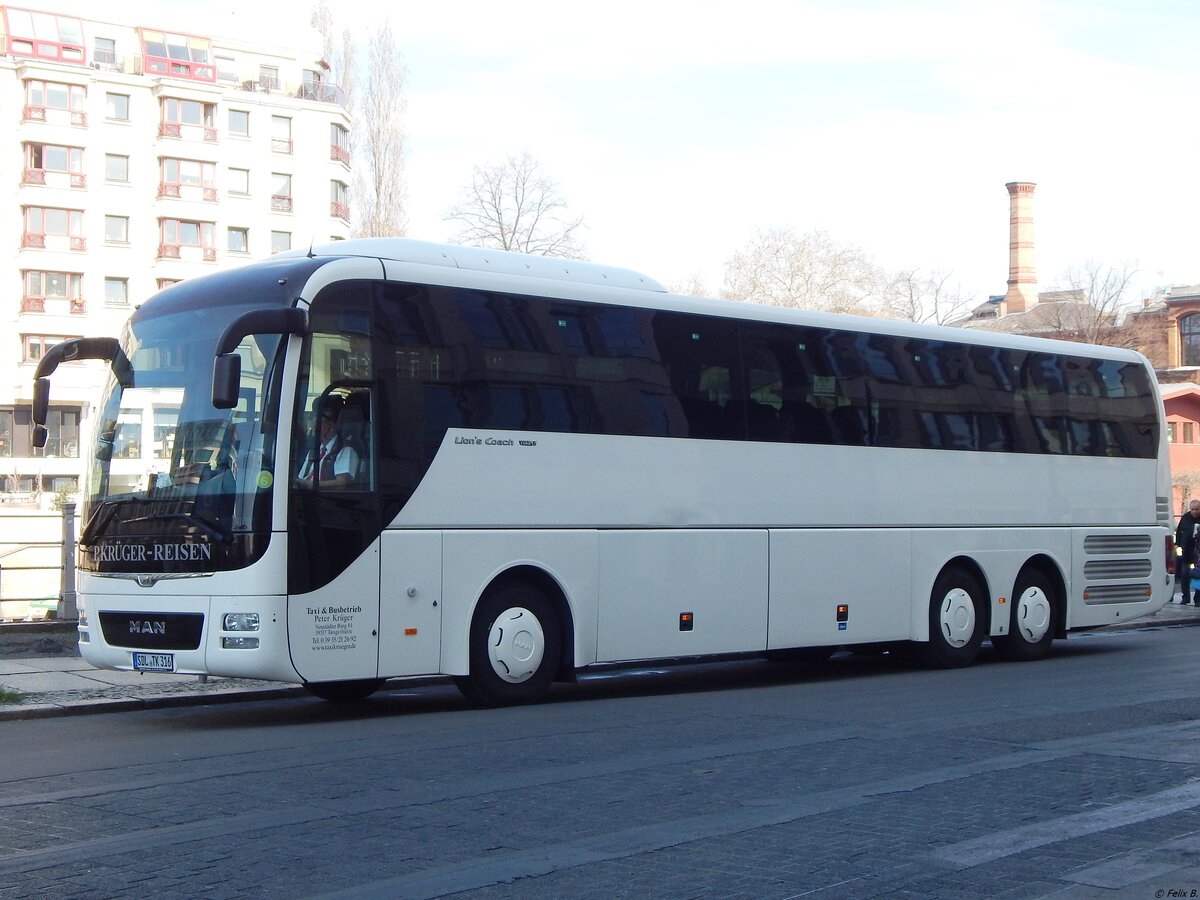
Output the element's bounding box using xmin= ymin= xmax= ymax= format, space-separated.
xmin=446 ymin=151 xmax=584 ymax=259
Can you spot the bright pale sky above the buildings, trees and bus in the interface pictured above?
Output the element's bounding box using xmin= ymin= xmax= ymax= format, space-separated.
xmin=39 ymin=0 xmax=1200 ymax=300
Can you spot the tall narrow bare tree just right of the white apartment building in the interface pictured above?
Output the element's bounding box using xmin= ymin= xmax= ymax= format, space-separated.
xmin=354 ymin=19 xmax=407 ymax=238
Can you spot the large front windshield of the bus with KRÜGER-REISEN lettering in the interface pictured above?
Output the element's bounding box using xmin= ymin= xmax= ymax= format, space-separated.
xmin=79 ymin=307 xmax=281 ymax=572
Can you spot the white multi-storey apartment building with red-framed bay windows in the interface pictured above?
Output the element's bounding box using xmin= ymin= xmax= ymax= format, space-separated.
xmin=0 ymin=6 xmax=350 ymax=505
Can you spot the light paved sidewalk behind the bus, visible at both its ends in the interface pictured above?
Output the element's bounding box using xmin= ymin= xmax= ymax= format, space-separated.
xmin=0 ymin=604 xmax=1200 ymax=721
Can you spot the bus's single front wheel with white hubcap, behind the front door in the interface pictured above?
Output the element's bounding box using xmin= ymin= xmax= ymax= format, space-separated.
xmin=455 ymin=582 xmax=563 ymax=707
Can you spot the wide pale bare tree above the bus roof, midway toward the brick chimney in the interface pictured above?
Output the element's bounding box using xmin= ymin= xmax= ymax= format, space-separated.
xmin=721 ymin=228 xmax=886 ymax=316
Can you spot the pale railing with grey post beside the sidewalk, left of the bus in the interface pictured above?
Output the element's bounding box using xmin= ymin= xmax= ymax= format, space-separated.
xmin=0 ymin=503 xmax=79 ymax=622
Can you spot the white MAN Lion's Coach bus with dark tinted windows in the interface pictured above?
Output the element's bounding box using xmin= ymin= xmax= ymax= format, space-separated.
xmin=34 ymin=239 xmax=1172 ymax=704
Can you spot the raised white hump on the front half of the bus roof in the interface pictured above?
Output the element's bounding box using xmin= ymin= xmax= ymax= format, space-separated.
xmin=275 ymin=238 xmax=666 ymax=293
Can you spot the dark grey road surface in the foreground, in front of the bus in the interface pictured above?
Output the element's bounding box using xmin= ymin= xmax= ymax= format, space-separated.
xmin=0 ymin=628 xmax=1200 ymax=899
